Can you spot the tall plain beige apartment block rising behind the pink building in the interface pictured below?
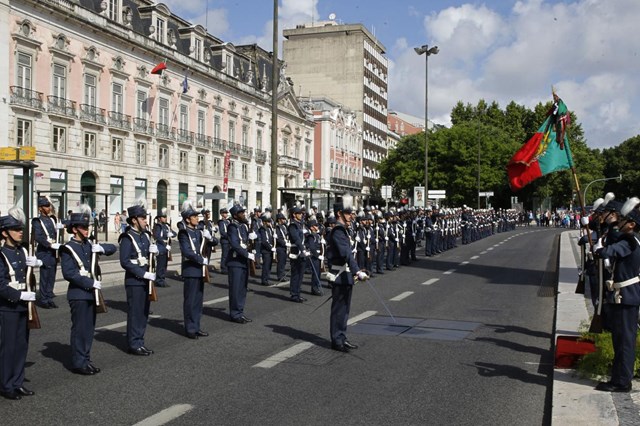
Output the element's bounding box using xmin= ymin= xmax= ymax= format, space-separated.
xmin=283 ymin=21 xmax=388 ymax=204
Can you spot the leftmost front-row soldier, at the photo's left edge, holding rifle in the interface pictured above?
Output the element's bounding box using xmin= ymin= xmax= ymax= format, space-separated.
xmin=0 ymin=207 xmax=42 ymax=399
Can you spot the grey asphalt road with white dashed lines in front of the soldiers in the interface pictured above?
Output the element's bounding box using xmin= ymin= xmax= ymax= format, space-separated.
xmin=0 ymin=227 xmax=559 ymax=425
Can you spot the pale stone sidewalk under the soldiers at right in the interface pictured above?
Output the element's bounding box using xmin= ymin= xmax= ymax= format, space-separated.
xmin=551 ymin=231 xmax=624 ymax=426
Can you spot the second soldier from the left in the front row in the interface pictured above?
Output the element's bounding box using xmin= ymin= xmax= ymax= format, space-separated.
xmin=60 ymin=205 xmax=116 ymax=376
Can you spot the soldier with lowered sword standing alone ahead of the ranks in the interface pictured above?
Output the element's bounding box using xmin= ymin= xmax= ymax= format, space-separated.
xmin=327 ymin=197 xmax=369 ymax=352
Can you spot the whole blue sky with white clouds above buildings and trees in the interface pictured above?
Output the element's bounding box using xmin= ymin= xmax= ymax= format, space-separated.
xmin=164 ymin=0 xmax=640 ymax=148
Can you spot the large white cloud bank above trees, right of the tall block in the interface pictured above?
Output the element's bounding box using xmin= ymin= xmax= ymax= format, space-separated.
xmin=389 ymin=0 xmax=640 ymax=147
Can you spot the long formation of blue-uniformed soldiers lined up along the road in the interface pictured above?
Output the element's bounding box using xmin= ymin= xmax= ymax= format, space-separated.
xmin=0 ymin=197 xmax=518 ymax=400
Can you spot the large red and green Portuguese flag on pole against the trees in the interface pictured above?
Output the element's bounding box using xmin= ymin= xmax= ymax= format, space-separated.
xmin=507 ymin=92 xmax=573 ymax=191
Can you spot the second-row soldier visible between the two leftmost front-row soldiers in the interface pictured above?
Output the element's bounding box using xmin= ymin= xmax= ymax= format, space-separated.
xmin=31 ymin=197 xmax=64 ymax=309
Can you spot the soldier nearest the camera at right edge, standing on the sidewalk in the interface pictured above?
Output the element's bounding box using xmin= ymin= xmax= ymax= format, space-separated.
xmin=593 ymin=197 xmax=640 ymax=392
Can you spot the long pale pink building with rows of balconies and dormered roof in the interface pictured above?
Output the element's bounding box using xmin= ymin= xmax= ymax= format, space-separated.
xmin=0 ymin=0 xmax=313 ymax=220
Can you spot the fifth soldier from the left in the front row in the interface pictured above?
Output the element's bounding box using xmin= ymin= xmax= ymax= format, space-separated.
xmin=224 ymin=205 xmax=255 ymax=324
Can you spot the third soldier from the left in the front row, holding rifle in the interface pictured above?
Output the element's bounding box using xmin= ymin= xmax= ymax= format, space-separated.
xmin=118 ymin=201 xmax=159 ymax=356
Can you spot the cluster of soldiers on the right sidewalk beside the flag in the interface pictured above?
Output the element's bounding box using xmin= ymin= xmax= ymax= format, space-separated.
xmin=576 ymin=193 xmax=640 ymax=392
